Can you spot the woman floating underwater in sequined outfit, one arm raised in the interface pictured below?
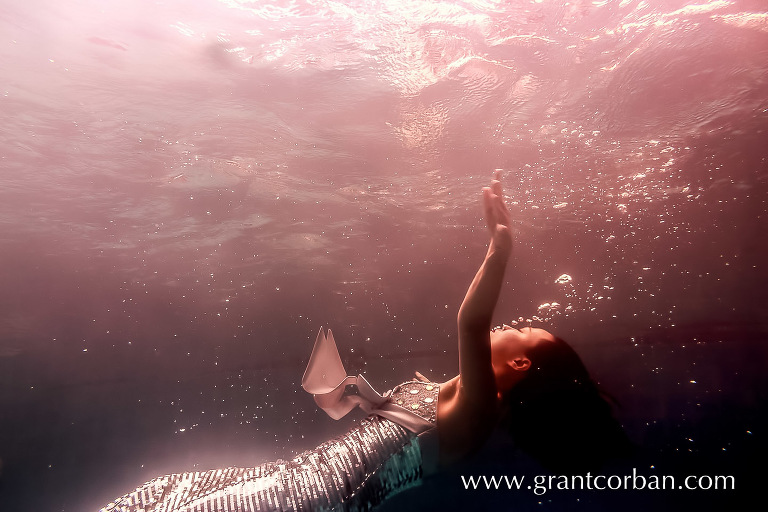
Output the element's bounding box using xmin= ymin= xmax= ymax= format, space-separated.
xmin=102 ymin=171 xmax=627 ymax=512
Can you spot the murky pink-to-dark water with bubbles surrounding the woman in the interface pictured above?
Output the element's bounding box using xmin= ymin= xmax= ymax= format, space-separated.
xmin=0 ymin=0 xmax=768 ymax=511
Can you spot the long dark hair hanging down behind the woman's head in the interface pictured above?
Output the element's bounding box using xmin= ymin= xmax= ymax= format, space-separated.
xmin=501 ymin=338 xmax=631 ymax=474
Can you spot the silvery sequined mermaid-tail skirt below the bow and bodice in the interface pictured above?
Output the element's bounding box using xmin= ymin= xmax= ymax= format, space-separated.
xmin=100 ymin=416 xmax=422 ymax=512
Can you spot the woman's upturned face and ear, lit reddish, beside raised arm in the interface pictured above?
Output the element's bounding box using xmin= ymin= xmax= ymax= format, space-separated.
xmin=491 ymin=325 xmax=555 ymax=392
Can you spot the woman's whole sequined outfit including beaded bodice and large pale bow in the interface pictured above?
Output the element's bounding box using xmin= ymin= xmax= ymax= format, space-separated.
xmin=101 ymin=329 xmax=439 ymax=512
